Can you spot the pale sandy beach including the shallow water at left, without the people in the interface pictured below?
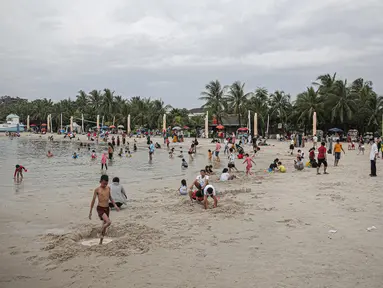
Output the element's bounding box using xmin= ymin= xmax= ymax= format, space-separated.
xmin=0 ymin=135 xmax=383 ymax=288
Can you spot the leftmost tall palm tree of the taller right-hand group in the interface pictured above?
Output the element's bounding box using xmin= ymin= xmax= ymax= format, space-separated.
xmin=199 ymin=80 xmax=226 ymax=123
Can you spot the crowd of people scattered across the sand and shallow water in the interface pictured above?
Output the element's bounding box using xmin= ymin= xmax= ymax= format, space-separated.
xmin=9 ymin=130 xmax=383 ymax=244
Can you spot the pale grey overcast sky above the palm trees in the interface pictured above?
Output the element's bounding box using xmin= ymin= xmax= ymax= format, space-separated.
xmin=0 ymin=0 xmax=383 ymax=108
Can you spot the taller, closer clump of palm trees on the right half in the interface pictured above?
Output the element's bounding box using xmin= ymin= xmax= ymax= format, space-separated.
xmin=200 ymin=73 xmax=383 ymax=134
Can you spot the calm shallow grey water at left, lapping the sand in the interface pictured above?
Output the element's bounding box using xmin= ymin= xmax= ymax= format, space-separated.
xmin=0 ymin=136 xmax=212 ymax=234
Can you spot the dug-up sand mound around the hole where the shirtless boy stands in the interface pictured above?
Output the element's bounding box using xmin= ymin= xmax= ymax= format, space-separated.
xmin=42 ymin=223 xmax=162 ymax=263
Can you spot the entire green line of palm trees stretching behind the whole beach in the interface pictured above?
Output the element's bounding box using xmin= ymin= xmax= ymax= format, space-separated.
xmin=0 ymin=73 xmax=383 ymax=134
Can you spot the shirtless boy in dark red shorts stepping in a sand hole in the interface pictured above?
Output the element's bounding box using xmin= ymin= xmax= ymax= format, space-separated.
xmin=89 ymin=175 xmax=120 ymax=245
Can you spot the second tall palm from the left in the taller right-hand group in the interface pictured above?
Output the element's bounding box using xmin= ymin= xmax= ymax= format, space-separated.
xmin=226 ymin=81 xmax=252 ymax=126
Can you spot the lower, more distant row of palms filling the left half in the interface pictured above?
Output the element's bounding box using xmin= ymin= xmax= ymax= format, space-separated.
xmin=0 ymin=89 xmax=204 ymax=130
